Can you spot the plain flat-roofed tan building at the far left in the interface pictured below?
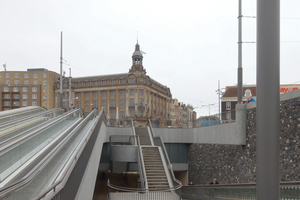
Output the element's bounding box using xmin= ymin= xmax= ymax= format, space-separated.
xmin=0 ymin=68 xmax=59 ymax=111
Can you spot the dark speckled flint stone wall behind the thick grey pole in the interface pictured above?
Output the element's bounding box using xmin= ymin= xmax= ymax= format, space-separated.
xmin=188 ymin=97 xmax=300 ymax=184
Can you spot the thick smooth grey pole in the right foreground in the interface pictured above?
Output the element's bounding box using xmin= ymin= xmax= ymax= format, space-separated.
xmin=256 ymin=0 xmax=280 ymax=200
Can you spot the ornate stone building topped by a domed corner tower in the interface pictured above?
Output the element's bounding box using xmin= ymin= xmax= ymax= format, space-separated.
xmin=54 ymin=43 xmax=172 ymax=126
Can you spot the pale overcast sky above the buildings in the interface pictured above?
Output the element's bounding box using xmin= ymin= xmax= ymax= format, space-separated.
xmin=0 ymin=0 xmax=300 ymax=117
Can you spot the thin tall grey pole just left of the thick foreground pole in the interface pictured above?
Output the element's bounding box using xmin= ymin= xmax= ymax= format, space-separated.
xmin=238 ymin=0 xmax=243 ymax=103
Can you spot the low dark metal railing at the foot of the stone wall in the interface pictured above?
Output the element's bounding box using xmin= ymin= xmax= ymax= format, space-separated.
xmin=182 ymin=182 xmax=300 ymax=200
